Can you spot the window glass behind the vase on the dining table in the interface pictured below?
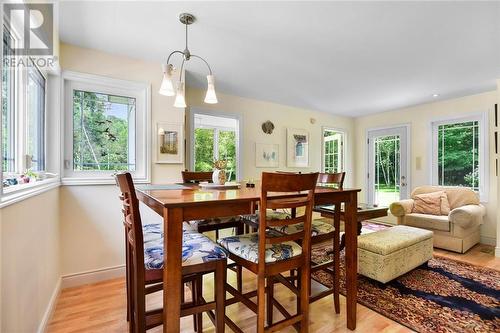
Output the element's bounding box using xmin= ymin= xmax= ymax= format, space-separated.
xmin=193 ymin=113 xmax=240 ymax=180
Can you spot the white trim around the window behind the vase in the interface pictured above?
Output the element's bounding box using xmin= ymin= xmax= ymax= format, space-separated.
xmin=189 ymin=109 xmax=244 ymax=181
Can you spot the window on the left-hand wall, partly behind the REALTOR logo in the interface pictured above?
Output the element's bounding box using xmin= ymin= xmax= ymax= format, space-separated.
xmin=1 ymin=27 xmax=49 ymax=195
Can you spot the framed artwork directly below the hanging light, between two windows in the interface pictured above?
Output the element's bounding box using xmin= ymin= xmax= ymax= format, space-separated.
xmin=155 ymin=122 xmax=184 ymax=164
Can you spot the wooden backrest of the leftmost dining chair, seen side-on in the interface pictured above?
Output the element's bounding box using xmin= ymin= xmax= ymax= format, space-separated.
xmin=116 ymin=172 xmax=145 ymax=285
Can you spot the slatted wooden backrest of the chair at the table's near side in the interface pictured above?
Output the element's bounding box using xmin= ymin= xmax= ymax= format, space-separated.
xmin=258 ymin=172 xmax=318 ymax=266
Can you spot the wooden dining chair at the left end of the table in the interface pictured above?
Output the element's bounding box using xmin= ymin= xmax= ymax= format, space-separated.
xmin=116 ymin=172 xmax=227 ymax=333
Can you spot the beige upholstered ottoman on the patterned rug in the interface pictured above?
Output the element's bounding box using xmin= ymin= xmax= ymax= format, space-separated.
xmin=358 ymin=225 xmax=432 ymax=283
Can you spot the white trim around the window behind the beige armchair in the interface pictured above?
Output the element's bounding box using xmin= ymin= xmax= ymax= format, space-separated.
xmin=429 ymin=111 xmax=490 ymax=202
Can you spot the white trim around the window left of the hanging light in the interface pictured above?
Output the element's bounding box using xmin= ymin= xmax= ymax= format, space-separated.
xmin=60 ymin=71 xmax=151 ymax=185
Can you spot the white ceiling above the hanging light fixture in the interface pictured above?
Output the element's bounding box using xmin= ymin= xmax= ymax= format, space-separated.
xmin=60 ymin=1 xmax=500 ymax=116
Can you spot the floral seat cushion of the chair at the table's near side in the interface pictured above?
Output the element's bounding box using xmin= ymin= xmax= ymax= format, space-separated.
xmin=218 ymin=230 xmax=302 ymax=263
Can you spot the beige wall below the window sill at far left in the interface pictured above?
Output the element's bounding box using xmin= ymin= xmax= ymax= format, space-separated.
xmin=0 ymin=188 xmax=61 ymax=333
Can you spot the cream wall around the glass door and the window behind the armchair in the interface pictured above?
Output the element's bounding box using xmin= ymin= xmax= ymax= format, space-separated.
xmin=354 ymin=91 xmax=498 ymax=245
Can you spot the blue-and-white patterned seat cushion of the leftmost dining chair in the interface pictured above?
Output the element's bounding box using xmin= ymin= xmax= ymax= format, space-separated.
xmin=144 ymin=232 xmax=227 ymax=269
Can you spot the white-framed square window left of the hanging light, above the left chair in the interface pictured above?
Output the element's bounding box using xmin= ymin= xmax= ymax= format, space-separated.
xmin=63 ymin=72 xmax=150 ymax=184
